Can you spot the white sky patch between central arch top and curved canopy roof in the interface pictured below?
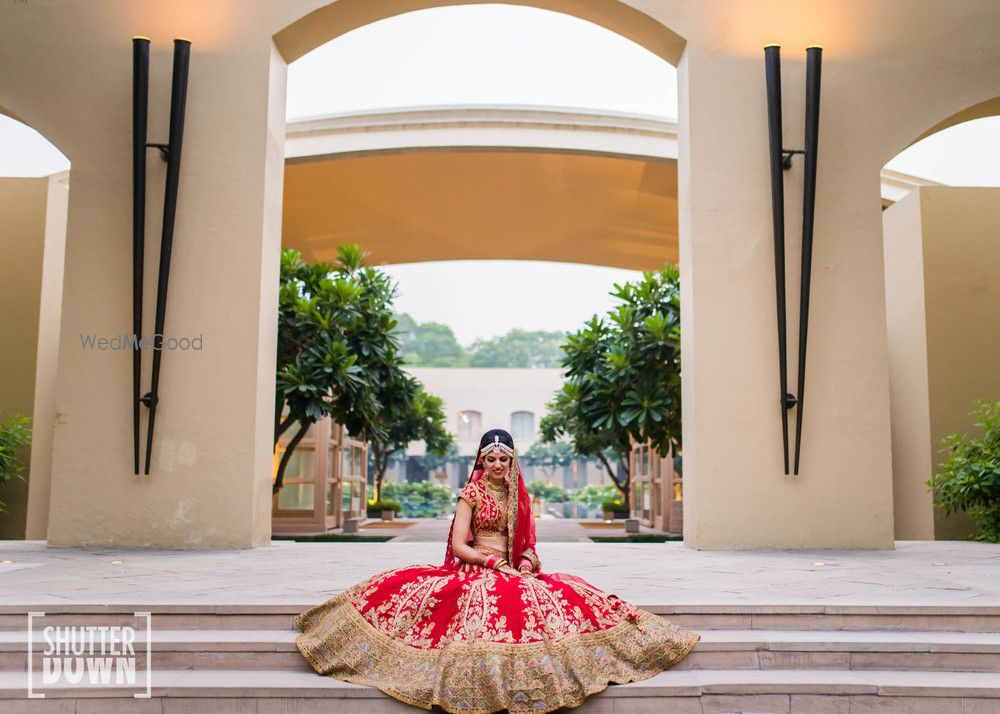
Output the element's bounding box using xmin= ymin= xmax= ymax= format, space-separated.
xmin=287 ymin=5 xmax=677 ymax=119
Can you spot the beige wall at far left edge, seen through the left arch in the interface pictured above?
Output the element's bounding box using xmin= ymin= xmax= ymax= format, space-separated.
xmin=0 ymin=173 xmax=69 ymax=538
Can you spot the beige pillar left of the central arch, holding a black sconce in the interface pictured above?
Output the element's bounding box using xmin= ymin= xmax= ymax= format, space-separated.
xmin=11 ymin=5 xmax=285 ymax=548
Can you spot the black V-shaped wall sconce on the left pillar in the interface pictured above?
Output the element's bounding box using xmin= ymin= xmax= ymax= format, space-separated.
xmin=132 ymin=37 xmax=191 ymax=476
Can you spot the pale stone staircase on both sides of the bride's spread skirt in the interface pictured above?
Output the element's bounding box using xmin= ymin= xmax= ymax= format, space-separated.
xmin=0 ymin=605 xmax=1000 ymax=714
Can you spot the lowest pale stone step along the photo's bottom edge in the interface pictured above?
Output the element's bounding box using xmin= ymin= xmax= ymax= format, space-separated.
xmin=0 ymin=669 xmax=1000 ymax=714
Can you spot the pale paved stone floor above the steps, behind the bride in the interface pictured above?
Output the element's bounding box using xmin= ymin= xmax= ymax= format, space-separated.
xmin=0 ymin=520 xmax=1000 ymax=607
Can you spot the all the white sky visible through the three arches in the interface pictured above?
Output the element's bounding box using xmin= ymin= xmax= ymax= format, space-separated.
xmin=0 ymin=5 xmax=1000 ymax=344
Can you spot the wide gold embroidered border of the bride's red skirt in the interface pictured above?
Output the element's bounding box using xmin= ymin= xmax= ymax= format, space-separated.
xmin=293 ymin=588 xmax=701 ymax=714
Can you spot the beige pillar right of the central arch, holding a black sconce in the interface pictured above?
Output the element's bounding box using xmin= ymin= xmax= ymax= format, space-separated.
xmin=679 ymin=46 xmax=893 ymax=549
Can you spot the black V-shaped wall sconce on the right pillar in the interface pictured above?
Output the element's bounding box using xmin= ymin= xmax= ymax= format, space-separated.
xmin=764 ymin=45 xmax=823 ymax=476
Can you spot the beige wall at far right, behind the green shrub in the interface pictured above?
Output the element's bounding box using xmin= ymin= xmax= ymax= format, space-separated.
xmin=884 ymin=186 xmax=1000 ymax=539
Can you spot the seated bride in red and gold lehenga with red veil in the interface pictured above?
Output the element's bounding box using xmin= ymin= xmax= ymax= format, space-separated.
xmin=294 ymin=429 xmax=701 ymax=714
